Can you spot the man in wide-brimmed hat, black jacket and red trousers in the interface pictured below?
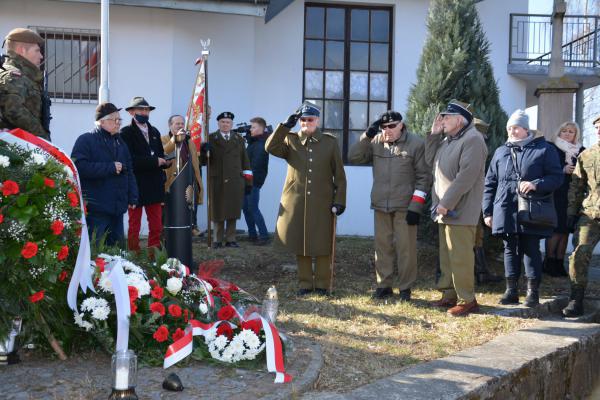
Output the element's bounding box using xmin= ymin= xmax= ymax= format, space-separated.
xmin=121 ymin=97 xmax=170 ymax=251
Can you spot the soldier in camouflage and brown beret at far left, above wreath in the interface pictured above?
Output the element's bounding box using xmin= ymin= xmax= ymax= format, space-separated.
xmin=0 ymin=28 xmax=50 ymax=139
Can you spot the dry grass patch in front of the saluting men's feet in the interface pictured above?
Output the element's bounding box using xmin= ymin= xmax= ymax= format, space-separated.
xmin=194 ymin=237 xmax=552 ymax=391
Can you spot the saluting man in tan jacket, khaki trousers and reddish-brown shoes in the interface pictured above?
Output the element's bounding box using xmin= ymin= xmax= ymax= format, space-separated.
xmin=425 ymin=101 xmax=487 ymax=316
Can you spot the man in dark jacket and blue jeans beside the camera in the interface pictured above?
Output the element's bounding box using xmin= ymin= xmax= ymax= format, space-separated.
xmin=243 ymin=117 xmax=269 ymax=246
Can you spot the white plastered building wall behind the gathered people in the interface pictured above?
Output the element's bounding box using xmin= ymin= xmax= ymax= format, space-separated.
xmin=0 ymin=0 xmax=527 ymax=235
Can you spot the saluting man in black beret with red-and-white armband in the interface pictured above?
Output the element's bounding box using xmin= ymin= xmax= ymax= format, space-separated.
xmin=348 ymin=111 xmax=431 ymax=301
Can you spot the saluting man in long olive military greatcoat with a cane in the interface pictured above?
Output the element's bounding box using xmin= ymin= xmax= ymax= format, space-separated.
xmin=265 ymin=104 xmax=346 ymax=296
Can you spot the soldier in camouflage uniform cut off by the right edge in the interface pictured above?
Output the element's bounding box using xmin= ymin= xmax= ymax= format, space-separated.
xmin=563 ymin=115 xmax=600 ymax=317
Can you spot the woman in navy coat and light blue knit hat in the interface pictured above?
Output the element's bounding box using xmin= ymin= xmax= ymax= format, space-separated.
xmin=483 ymin=110 xmax=563 ymax=307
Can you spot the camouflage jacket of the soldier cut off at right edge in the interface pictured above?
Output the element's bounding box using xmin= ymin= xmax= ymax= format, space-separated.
xmin=567 ymin=143 xmax=600 ymax=219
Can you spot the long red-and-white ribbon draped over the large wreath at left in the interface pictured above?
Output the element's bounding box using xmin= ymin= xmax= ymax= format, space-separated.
xmin=0 ymin=129 xmax=95 ymax=310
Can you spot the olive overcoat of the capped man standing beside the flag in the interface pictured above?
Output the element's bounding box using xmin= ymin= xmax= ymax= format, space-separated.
xmin=202 ymin=131 xmax=252 ymax=222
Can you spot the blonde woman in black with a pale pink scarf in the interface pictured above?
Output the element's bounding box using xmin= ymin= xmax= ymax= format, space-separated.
xmin=543 ymin=121 xmax=585 ymax=276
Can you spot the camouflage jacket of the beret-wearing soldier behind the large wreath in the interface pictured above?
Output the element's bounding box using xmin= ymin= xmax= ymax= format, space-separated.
xmin=0 ymin=51 xmax=49 ymax=139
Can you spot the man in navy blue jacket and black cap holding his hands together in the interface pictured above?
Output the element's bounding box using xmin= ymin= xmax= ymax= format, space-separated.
xmin=71 ymin=103 xmax=138 ymax=247
